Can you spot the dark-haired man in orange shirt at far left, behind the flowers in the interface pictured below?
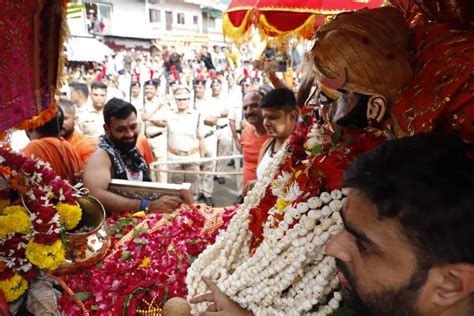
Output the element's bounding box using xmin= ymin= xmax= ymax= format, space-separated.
xmin=22 ymin=107 xmax=84 ymax=184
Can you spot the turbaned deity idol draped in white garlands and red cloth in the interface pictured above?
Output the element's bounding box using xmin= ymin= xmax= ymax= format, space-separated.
xmin=186 ymin=7 xmax=474 ymax=315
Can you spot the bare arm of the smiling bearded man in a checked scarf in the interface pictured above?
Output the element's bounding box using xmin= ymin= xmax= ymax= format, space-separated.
xmin=82 ymin=148 xmax=182 ymax=213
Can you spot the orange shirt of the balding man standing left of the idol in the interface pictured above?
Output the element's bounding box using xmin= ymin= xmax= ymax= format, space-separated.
xmin=240 ymin=125 xmax=268 ymax=187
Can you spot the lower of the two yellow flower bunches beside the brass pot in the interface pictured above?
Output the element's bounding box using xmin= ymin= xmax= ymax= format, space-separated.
xmin=26 ymin=239 xmax=65 ymax=270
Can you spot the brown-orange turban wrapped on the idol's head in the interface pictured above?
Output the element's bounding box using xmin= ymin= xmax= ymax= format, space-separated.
xmin=312 ymin=7 xmax=412 ymax=101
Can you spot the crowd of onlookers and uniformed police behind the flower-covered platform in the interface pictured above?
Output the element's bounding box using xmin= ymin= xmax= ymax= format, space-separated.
xmin=13 ymin=42 xmax=304 ymax=211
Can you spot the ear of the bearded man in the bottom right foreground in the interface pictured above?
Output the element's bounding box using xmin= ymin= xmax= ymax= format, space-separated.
xmin=433 ymin=263 xmax=474 ymax=306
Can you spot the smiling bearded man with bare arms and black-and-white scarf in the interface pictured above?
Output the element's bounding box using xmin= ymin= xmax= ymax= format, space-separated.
xmin=83 ymin=98 xmax=182 ymax=212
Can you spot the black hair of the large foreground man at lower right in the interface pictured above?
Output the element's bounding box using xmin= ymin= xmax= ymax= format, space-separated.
xmin=344 ymin=134 xmax=474 ymax=266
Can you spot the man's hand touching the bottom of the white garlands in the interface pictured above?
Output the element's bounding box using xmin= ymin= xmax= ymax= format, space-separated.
xmin=189 ymin=277 xmax=253 ymax=316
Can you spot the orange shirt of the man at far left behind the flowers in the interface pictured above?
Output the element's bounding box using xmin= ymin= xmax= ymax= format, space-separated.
xmin=22 ymin=137 xmax=84 ymax=184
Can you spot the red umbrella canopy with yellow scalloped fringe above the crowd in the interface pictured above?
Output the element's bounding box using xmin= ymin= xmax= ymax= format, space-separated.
xmin=223 ymin=0 xmax=384 ymax=42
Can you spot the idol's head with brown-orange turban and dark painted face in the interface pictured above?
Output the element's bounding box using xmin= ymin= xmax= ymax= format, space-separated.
xmin=309 ymin=7 xmax=411 ymax=131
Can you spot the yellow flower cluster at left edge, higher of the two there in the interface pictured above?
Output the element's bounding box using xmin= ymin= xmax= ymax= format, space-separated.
xmin=0 ymin=205 xmax=31 ymax=238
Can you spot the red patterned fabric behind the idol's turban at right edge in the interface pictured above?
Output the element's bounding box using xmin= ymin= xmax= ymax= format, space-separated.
xmin=393 ymin=24 xmax=474 ymax=135
